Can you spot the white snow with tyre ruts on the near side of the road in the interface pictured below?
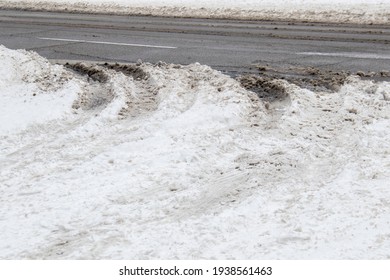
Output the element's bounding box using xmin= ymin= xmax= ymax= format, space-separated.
xmin=0 ymin=44 xmax=390 ymax=259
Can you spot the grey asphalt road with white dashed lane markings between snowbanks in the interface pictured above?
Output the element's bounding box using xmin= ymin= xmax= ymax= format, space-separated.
xmin=0 ymin=10 xmax=390 ymax=73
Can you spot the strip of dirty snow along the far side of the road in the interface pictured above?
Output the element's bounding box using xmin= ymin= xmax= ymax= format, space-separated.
xmin=0 ymin=0 xmax=390 ymax=24
